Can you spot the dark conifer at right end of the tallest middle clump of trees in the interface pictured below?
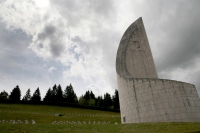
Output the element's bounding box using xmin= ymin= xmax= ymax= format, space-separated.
xmin=64 ymin=84 xmax=78 ymax=103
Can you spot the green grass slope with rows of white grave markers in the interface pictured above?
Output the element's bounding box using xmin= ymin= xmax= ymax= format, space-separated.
xmin=0 ymin=104 xmax=200 ymax=133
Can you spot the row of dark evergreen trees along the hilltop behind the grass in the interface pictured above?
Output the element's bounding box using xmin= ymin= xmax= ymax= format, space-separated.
xmin=0 ymin=84 xmax=119 ymax=109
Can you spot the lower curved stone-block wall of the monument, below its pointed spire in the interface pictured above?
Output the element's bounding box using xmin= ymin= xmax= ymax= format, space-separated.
xmin=117 ymin=75 xmax=200 ymax=123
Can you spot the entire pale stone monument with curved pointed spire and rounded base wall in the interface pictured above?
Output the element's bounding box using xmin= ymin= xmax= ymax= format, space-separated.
xmin=116 ymin=18 xmax=200 ymax=123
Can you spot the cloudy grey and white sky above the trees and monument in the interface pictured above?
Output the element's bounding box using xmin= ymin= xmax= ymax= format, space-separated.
xmin=0 ymin=0 xmax=200 ymax=96
